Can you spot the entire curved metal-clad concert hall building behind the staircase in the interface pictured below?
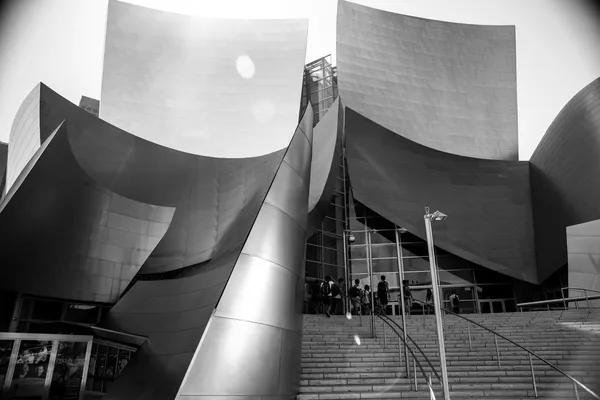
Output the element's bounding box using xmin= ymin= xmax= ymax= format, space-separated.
xmin=0 ymin=0 xmax=600 ymax=400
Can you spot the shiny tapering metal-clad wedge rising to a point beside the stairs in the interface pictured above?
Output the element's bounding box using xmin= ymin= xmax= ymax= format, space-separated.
xmin=177 ymin=107 xmax=313 ymax=399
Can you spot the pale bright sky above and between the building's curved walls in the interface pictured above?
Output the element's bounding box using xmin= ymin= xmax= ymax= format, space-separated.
xmin=0 ymin=0 xmax=600 ymax=160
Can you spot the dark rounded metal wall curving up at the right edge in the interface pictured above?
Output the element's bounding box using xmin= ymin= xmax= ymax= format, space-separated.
xmin=530 ymin=78 xmax=600 ymax=280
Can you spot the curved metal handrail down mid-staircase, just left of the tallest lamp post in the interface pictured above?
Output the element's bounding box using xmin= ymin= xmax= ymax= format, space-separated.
xmin=341 ymin=293 xmax=442 ymax=400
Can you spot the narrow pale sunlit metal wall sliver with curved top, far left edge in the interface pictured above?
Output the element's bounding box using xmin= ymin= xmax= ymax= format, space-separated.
xmin=3 ymin=84 xmax=41 ymax=193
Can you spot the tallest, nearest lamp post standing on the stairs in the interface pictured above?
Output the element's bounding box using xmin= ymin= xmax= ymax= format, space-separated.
xmin=424 ymin=207 xmax=450 ymax=400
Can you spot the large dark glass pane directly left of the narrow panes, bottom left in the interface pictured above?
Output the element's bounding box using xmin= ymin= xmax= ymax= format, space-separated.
xmin=49 ymin=341 xmax=88 ymax=400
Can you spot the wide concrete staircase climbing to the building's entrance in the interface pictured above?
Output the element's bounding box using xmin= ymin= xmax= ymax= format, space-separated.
xmin=298 ymin=310 xmax=600 ymax=400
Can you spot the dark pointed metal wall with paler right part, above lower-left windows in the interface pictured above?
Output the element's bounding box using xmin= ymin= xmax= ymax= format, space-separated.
xmin=0 ymin=124 xmax=175 ymax=302
